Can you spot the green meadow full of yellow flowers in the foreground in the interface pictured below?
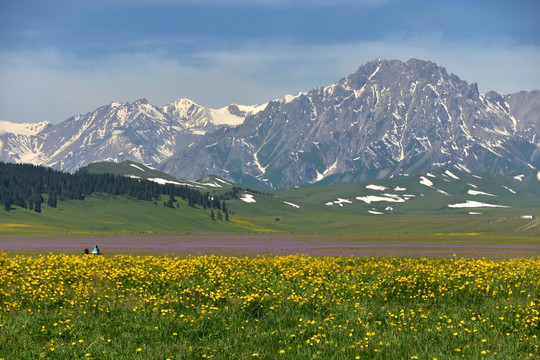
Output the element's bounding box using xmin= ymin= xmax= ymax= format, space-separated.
xmin=0 ymin=252 xmax=540 ymax=360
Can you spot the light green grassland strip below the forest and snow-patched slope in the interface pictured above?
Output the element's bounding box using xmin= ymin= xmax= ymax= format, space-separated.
xmin=0 ymin=194 xmax=540 ymax=239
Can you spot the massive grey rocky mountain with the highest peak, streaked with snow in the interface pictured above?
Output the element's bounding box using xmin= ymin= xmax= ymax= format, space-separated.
xmin=162 ymin=59 xmax=540 ymax=188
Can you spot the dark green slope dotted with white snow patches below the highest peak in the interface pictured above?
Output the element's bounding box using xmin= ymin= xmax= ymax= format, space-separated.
xmin=279 ymin=167 xmax=540 ymax=215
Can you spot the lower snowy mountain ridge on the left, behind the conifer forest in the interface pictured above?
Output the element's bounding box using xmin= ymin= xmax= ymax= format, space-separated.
xmin=0 ymin=99 xmax=266 ymax=172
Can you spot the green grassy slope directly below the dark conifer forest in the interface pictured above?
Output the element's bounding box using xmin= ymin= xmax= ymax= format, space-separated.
xmin=0 ymin=194 xmax=252 ymax=236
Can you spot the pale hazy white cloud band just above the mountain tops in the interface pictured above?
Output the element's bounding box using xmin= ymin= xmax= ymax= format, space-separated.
xmin=0 ymin=36 xmax=540 ymax=123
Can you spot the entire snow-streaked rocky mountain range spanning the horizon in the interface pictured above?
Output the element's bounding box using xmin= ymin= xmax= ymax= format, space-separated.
xmin=0 ymin=59 xmax=540 ymax=188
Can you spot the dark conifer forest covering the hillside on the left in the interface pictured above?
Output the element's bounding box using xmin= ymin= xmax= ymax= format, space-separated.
xmin=0 ymin=162 xmax=240 ymax=219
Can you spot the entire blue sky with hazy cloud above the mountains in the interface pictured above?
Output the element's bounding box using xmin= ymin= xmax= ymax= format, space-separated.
xmin=0 ymin=0 xmax=540 ymax=123
